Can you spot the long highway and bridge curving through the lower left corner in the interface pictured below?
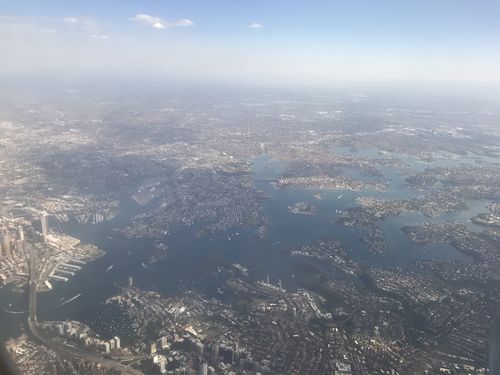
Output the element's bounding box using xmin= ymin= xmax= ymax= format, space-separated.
xmin=28 ymin=246 xmax=144 ymax=375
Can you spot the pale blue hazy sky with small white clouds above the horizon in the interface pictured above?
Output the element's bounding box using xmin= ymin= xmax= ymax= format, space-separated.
xmin=0 ymin=0 xmax=500 ymax=85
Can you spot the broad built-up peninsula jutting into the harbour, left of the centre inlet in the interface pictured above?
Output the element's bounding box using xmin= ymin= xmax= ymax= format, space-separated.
xmin=121 ymin=169 xmax=261 ymax=238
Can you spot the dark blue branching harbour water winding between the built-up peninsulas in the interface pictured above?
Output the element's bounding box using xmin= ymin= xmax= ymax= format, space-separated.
xmin=0 ymin=156 xmax=487 ymax=339
